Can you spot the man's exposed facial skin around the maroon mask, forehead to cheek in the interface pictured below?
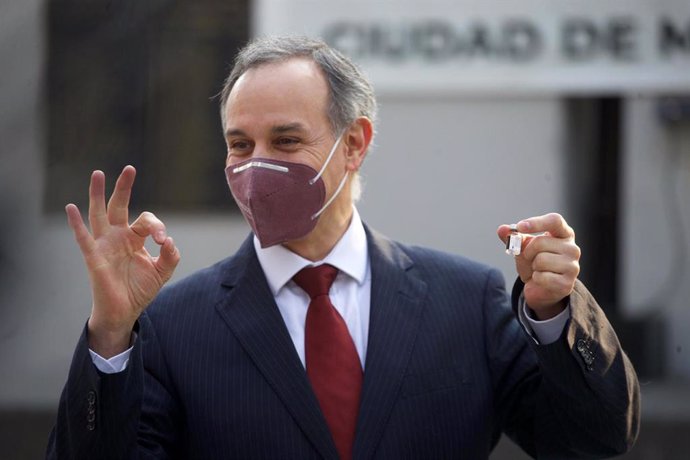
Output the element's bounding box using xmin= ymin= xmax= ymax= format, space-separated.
xmin=224 ymin=58 xmax=345 ymax=196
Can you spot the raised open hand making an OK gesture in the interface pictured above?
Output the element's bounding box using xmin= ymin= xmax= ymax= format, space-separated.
xmin=65 ymin=166 xmax=180 ymax=359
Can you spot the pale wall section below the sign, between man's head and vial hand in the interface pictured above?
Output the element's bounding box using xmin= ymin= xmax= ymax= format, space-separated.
xmin=359 ymin=98 xmax=564 ymax=283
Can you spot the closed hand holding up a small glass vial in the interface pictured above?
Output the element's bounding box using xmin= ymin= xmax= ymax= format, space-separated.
xmin=497 ymin=213 xmax=580 ymax=321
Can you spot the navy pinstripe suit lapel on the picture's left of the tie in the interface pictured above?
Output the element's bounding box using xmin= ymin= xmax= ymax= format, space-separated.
xmin=216 ymin=237 xmax=338 ymax=458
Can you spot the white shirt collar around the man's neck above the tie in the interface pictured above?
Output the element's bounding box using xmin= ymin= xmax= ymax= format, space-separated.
xmin=254 ymin=207 xmax=368 ymax=296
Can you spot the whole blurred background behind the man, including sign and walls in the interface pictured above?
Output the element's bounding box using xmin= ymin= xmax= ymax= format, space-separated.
xmin=0 ymin=0 xmax=690 ymax=460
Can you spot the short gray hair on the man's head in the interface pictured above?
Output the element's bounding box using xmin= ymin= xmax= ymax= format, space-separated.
xmin=220 ymin=36 xmax=376 ymax=136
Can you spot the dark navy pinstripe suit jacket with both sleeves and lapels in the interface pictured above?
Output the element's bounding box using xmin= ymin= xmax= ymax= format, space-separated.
xmin=48 ymin=229 xmax=639 ymax=459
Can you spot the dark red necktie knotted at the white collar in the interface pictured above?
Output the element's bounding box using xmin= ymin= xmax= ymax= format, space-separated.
xmin=293 ymin=264 xmax=362 ymax=460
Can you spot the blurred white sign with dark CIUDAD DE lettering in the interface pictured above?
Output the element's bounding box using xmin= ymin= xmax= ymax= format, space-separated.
xmin=253 ymin=0 xmax=690 ymax=94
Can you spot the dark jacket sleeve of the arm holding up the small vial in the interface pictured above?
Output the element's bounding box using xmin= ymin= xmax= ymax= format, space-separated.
xmin=488 ymin=272 xmax=640 ymax=459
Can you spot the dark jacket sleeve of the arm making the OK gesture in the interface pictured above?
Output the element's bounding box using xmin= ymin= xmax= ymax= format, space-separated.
xmin=46 ymin=315 xmax=179 ymax=459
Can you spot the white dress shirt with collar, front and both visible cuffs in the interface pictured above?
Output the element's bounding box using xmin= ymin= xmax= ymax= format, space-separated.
xmin=89 ymin=208 xmax=570 ymax=374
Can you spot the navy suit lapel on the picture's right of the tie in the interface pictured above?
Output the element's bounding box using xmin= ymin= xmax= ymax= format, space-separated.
xmin=354 ymin=227 xmax=427 ymax=459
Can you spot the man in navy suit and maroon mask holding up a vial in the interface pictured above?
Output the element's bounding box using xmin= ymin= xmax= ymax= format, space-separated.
xmin=48 ymin=38 xmax=639 ymax=459
